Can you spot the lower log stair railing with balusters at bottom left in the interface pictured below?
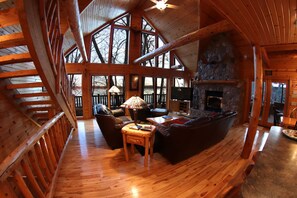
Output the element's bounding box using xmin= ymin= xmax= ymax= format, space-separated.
xmin=0 ymin=112 xmax=74 ymax=197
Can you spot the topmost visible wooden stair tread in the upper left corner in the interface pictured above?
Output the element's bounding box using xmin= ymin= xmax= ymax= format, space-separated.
xmin=0 ymin=8 xmax=19 ymax=28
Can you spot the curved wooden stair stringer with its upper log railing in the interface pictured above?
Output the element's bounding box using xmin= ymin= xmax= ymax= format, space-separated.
xmin=16 ymin=0 xmax=76 ymax=126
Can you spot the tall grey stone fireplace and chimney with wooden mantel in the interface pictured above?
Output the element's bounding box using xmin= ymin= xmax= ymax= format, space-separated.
xmin=191 ymin=34 xmax=244 ymax=123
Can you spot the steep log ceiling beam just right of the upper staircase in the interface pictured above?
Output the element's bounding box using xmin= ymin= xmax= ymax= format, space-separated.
xmin=62 ymin=0 xmax=88 ymax=62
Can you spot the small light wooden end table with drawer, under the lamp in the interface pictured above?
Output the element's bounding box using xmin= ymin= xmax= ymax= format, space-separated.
xmin=122 ymin=123 xmax=156 ymax=166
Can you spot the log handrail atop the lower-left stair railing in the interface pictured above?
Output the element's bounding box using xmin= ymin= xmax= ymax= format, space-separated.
xmin=0 ymin=112 xmax=64 ymax=181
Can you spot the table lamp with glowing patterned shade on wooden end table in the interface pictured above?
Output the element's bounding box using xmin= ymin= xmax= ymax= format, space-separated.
xmin=121 ymin=96 xmax=147 ymax=129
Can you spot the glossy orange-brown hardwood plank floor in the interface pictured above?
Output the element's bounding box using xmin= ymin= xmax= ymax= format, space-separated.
xmin=54 ymin=119 xmax=268 ymax=198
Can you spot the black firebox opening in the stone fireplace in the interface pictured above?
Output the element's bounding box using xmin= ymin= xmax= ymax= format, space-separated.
xmin=205 ymin=90 xmax=223 ymax=112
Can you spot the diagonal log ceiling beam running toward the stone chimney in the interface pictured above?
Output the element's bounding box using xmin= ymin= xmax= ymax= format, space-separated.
xmin=133 ymin=20 xmax=233 ymax=63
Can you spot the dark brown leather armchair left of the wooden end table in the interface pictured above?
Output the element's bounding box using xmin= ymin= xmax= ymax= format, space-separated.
xmin=95 ymin=105 xmax=133 ymax=149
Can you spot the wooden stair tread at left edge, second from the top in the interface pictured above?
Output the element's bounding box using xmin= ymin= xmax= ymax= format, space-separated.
xmin=0 ymin=33 xmax=26 ymax=49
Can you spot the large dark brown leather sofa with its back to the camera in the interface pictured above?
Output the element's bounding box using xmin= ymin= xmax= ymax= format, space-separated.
xmin=155 ymin=112 xmax=237 ymax=164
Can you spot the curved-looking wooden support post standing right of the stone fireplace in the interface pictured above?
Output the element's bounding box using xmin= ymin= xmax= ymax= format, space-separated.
xmin=241 ymin=46 xmax=263 ymax=159
